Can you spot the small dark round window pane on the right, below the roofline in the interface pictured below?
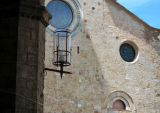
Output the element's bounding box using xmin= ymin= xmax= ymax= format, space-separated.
xmin=120 ymin=43 xmax=136 ymax=62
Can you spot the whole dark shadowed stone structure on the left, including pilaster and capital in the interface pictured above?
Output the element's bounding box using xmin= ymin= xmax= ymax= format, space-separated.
xmin=0 ymin=0 xmax=49 ymax=113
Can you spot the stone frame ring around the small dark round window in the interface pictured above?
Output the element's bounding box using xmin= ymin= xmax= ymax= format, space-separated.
xmin=119 ymin=40 xmax=139 ymax=64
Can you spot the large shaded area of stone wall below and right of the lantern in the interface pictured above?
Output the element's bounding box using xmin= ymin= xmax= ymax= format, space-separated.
xmin=44 ymin=25 xmax=110 ymax=113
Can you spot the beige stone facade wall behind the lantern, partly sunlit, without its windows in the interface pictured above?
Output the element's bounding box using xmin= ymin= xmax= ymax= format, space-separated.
xmin=43 ymin=0 xmax=160 ymax=113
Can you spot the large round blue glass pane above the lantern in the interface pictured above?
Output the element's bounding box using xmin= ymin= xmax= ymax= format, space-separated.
xmin=47 ymin=0 xmax=73 ymax=29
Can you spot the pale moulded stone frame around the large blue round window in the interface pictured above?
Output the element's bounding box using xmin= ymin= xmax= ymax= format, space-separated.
xmin=45 ymin=0 xmax=83 ymax=36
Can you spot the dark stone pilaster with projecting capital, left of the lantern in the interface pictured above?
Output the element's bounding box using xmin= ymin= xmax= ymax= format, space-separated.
xmin=16 ymin=1 xmax=49 ymax=113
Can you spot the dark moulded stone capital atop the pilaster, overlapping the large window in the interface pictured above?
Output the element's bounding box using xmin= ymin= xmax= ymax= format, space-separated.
xmin=19 ymin=2 xmax=51 ymax=26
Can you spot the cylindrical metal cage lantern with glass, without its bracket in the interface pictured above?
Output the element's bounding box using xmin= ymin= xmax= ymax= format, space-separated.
xmin=53 ymin=29 xmax=71 ymax=66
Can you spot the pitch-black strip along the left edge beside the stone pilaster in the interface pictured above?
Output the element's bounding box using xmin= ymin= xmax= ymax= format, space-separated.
xmin=0 ymin=0 xmax=19 ymax=113
